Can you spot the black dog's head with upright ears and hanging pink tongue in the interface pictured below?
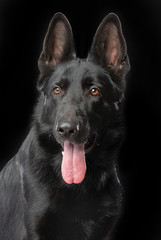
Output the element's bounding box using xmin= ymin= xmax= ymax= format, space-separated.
xmin=36 ymin=13 xmax=129 ymax=183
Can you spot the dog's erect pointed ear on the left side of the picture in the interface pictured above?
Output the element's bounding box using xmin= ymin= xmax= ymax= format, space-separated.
xmin=38 ymin=13 xmax=75 ymax=72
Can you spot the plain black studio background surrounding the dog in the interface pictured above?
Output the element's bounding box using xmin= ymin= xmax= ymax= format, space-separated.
xmin=0 ymin=0 xmax=161 ymax=240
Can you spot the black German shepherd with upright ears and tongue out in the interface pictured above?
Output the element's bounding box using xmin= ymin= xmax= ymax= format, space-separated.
xmin=0 ymin=13 xmax=129 ymax=240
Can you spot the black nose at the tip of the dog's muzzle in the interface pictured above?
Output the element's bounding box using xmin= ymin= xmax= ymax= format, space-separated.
xmin=56 ymin=122 xmax=79 ymax=137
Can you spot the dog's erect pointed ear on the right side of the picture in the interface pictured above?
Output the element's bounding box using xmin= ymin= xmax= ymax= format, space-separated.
xmin=89 ymin=13 xmax=130 ymax=79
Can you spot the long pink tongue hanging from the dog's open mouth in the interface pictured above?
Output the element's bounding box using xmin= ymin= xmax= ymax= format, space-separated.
xmin=61 ymin=141 xmax=86 ymax=184
